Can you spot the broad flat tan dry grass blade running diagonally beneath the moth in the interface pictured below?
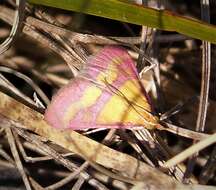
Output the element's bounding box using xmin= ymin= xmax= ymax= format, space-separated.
xmin=0 ymin=93 xmax=214 ymax=190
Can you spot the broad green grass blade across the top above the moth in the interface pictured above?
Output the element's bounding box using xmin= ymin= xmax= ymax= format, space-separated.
xmin=28 ymin=0 xmax=216 ymax=44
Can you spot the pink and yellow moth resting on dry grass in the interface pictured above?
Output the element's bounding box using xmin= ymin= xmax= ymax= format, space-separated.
xmin=45 ymin=46 xmax=158 ymax=130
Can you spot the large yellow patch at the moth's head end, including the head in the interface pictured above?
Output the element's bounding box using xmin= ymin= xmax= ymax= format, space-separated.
xmin=97 ymin=80 xmax=158 ymax=128
